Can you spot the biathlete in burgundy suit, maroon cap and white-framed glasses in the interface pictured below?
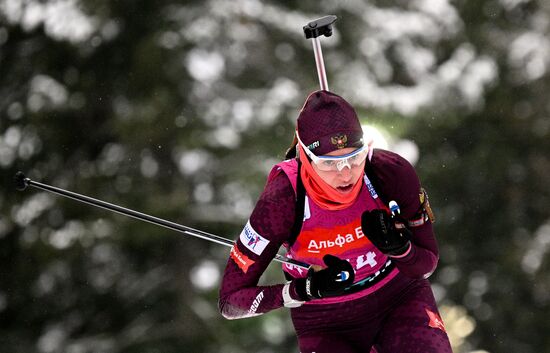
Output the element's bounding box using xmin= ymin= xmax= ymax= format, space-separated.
xmin=219 ymin=91 xmax=452 ymax=353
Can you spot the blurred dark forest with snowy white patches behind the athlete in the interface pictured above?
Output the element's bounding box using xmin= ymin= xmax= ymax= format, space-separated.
xmin=0 ymin=0 xmax=550 ymax=353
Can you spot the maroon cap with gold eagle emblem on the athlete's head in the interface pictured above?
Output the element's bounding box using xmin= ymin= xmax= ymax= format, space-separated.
xmin=298 ymin=91 xmax=363 ymax=156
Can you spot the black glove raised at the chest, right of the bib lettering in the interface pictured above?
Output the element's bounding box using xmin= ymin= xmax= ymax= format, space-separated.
xmin=361 ymin=209 xmax=411 ymax=256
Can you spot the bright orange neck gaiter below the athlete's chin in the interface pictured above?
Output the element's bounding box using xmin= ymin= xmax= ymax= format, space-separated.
xmin=299 ymin=146 xmax=363 ymax=210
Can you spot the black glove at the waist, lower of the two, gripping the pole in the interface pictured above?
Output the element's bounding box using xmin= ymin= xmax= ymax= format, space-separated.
xmin=295 ymin=255 xmax=355 ymax=301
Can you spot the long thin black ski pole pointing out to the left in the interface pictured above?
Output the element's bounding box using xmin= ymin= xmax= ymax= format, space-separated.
xmin=14 ymin=172 xmax=310 ymax=269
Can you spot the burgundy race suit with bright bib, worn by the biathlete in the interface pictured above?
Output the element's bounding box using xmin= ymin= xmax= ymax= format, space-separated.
xmin=219 ymin=149 xmax=451 ymax=353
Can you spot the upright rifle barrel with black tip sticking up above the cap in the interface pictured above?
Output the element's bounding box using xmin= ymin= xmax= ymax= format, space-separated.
xmin=304 ymin=15 xmax=337 ymax=91
